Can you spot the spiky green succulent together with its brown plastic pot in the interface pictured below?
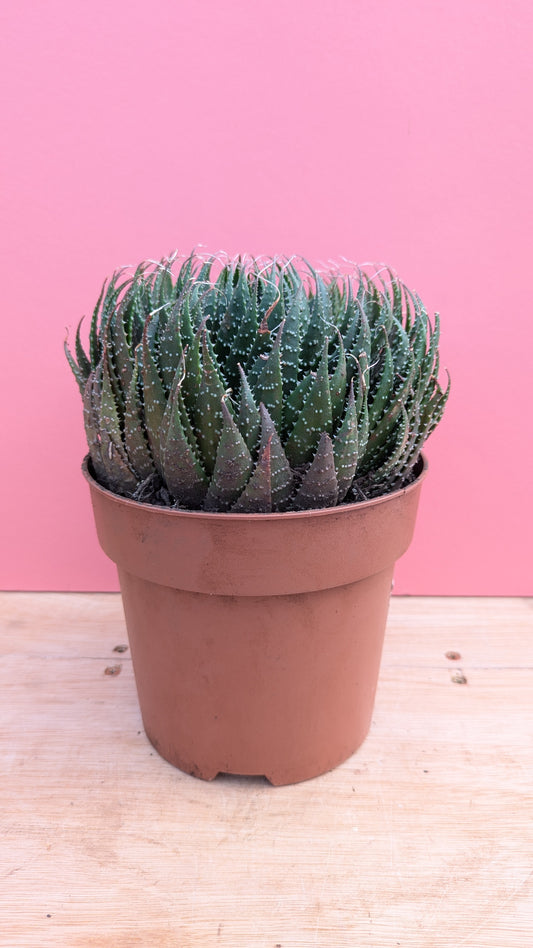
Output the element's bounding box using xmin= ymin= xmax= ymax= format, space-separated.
xmin=65 ymin=253 xmax=449 ymax=784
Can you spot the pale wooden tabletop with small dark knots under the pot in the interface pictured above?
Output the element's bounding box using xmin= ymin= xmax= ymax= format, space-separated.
xmin=0 ymin=593 xmax=533 ymax=948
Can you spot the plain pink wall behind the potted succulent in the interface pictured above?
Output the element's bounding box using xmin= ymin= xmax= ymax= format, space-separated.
xmin=0 ymin=0 xmax=533 ymax=595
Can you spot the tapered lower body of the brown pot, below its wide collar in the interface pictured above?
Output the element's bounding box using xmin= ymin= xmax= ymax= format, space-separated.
xmin=119 ymin=568 xmax=392 ymax=786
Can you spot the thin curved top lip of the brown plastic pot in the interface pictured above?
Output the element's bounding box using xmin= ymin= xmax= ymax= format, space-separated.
xmin=81 ymin=452 xmax=428 ymax=523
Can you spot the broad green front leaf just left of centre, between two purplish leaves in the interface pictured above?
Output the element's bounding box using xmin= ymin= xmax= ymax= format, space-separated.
xmin=204 ymin=399 xmax=253 ymax=511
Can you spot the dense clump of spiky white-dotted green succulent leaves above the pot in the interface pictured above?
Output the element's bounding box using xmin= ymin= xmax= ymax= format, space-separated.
xmin=65 ymin=253 xmax=449 ymax=513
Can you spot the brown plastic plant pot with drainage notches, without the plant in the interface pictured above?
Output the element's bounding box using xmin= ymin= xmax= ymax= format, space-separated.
xmin=83 ymin=458 xmax=427 ymax=785
